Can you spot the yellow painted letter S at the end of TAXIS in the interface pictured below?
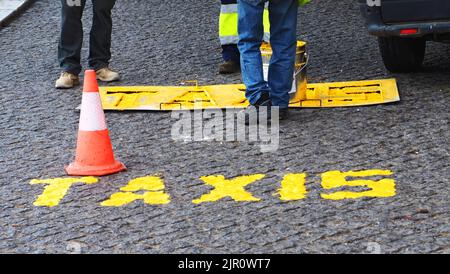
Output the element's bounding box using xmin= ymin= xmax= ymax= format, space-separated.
xmin=321 ymin=169 xmax=396 ymax=200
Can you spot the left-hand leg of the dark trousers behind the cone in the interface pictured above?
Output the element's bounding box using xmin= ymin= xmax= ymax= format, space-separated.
xmin=58 ymin=0 xmax=86 ymax=75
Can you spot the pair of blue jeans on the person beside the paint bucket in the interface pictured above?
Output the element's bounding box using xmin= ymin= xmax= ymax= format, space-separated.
xmin=238 ymin=0 xmax=298 ymax=108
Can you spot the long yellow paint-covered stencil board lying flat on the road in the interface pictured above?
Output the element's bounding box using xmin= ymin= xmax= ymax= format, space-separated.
xmin=100 ymin=79 xmax=400 ymax=111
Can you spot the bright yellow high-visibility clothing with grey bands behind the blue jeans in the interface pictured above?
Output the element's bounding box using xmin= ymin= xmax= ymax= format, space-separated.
xmin=219 ymin=4 xmax=270 ymax=45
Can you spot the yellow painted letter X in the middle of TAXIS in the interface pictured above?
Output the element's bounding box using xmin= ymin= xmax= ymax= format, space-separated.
xmin=192 ymin=174 xmax=265 ymax=204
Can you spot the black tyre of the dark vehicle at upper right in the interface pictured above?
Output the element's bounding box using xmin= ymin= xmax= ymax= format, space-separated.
xmin=378 ymin=37 xmax=426 ymax=72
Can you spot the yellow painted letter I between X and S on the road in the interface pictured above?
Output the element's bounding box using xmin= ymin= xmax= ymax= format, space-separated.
xmin=274 ymin=173 xmax=307 ymax=201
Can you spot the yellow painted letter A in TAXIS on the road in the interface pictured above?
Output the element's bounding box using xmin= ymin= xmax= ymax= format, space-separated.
xmin=101 ymin=176 xmax=170 ymax=206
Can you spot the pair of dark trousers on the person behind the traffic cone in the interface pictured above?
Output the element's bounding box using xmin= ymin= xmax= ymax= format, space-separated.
xmin=58 ymin=0 xmax=116 ymax=75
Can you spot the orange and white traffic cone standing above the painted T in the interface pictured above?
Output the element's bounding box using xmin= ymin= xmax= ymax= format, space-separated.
xmin=66 ymin=70 xmax=126 ymax=176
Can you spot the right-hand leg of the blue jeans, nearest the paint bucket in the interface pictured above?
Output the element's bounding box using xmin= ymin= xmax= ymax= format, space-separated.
xmin=268 ymin=0 xmax=298 ymax=108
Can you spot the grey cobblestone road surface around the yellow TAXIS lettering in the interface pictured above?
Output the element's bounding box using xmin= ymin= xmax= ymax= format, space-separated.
xmin=0 ymin=0 xmax=450 ymax=253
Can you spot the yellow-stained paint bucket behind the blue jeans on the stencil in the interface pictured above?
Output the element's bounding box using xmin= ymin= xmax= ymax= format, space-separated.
xmin=261 ymin=41 xmax=308 ymax=103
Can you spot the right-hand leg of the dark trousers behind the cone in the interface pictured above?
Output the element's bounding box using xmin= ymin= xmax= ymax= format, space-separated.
xmin=89 ymin=0 xmax=116 ymax=70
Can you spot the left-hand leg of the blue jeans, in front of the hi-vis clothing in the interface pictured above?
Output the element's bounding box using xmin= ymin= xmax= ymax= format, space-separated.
xmin=238 ymin=0 xmax=268 ymax=105
